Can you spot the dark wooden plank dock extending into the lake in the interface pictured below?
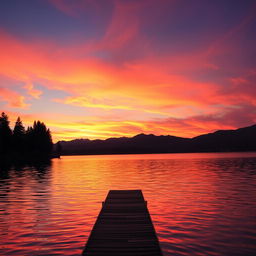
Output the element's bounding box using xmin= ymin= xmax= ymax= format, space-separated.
xmin=83 ymin=190 xmax=163 ymax=256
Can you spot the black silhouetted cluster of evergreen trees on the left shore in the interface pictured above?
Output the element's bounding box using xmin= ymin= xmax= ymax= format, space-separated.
xmin=0 ymin=112 xmax=53 ymax=160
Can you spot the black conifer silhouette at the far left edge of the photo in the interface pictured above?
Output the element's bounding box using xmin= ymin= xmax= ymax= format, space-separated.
xmin=0 ymin=112 xmax=12 ymax=154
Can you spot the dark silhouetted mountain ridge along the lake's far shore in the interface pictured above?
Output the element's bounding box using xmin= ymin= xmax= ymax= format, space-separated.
xmin=56 ymin=125 xmax=256 ymax=155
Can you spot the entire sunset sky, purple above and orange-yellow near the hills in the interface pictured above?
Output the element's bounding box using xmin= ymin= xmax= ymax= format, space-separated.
xmin=0 ymin=0 xmax=256 ymax=142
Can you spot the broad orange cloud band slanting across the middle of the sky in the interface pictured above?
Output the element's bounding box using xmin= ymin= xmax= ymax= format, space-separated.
xmin=0 ymin=29 xmax=218 ymax=112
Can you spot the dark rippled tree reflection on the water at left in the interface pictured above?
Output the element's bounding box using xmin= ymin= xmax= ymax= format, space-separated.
xmin=0 ymin=161 xmax=51 ymax=255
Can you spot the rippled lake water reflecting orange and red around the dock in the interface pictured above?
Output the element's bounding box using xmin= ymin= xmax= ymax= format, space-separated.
xmin=0 ymin=153 xmax=256 ymax=256
